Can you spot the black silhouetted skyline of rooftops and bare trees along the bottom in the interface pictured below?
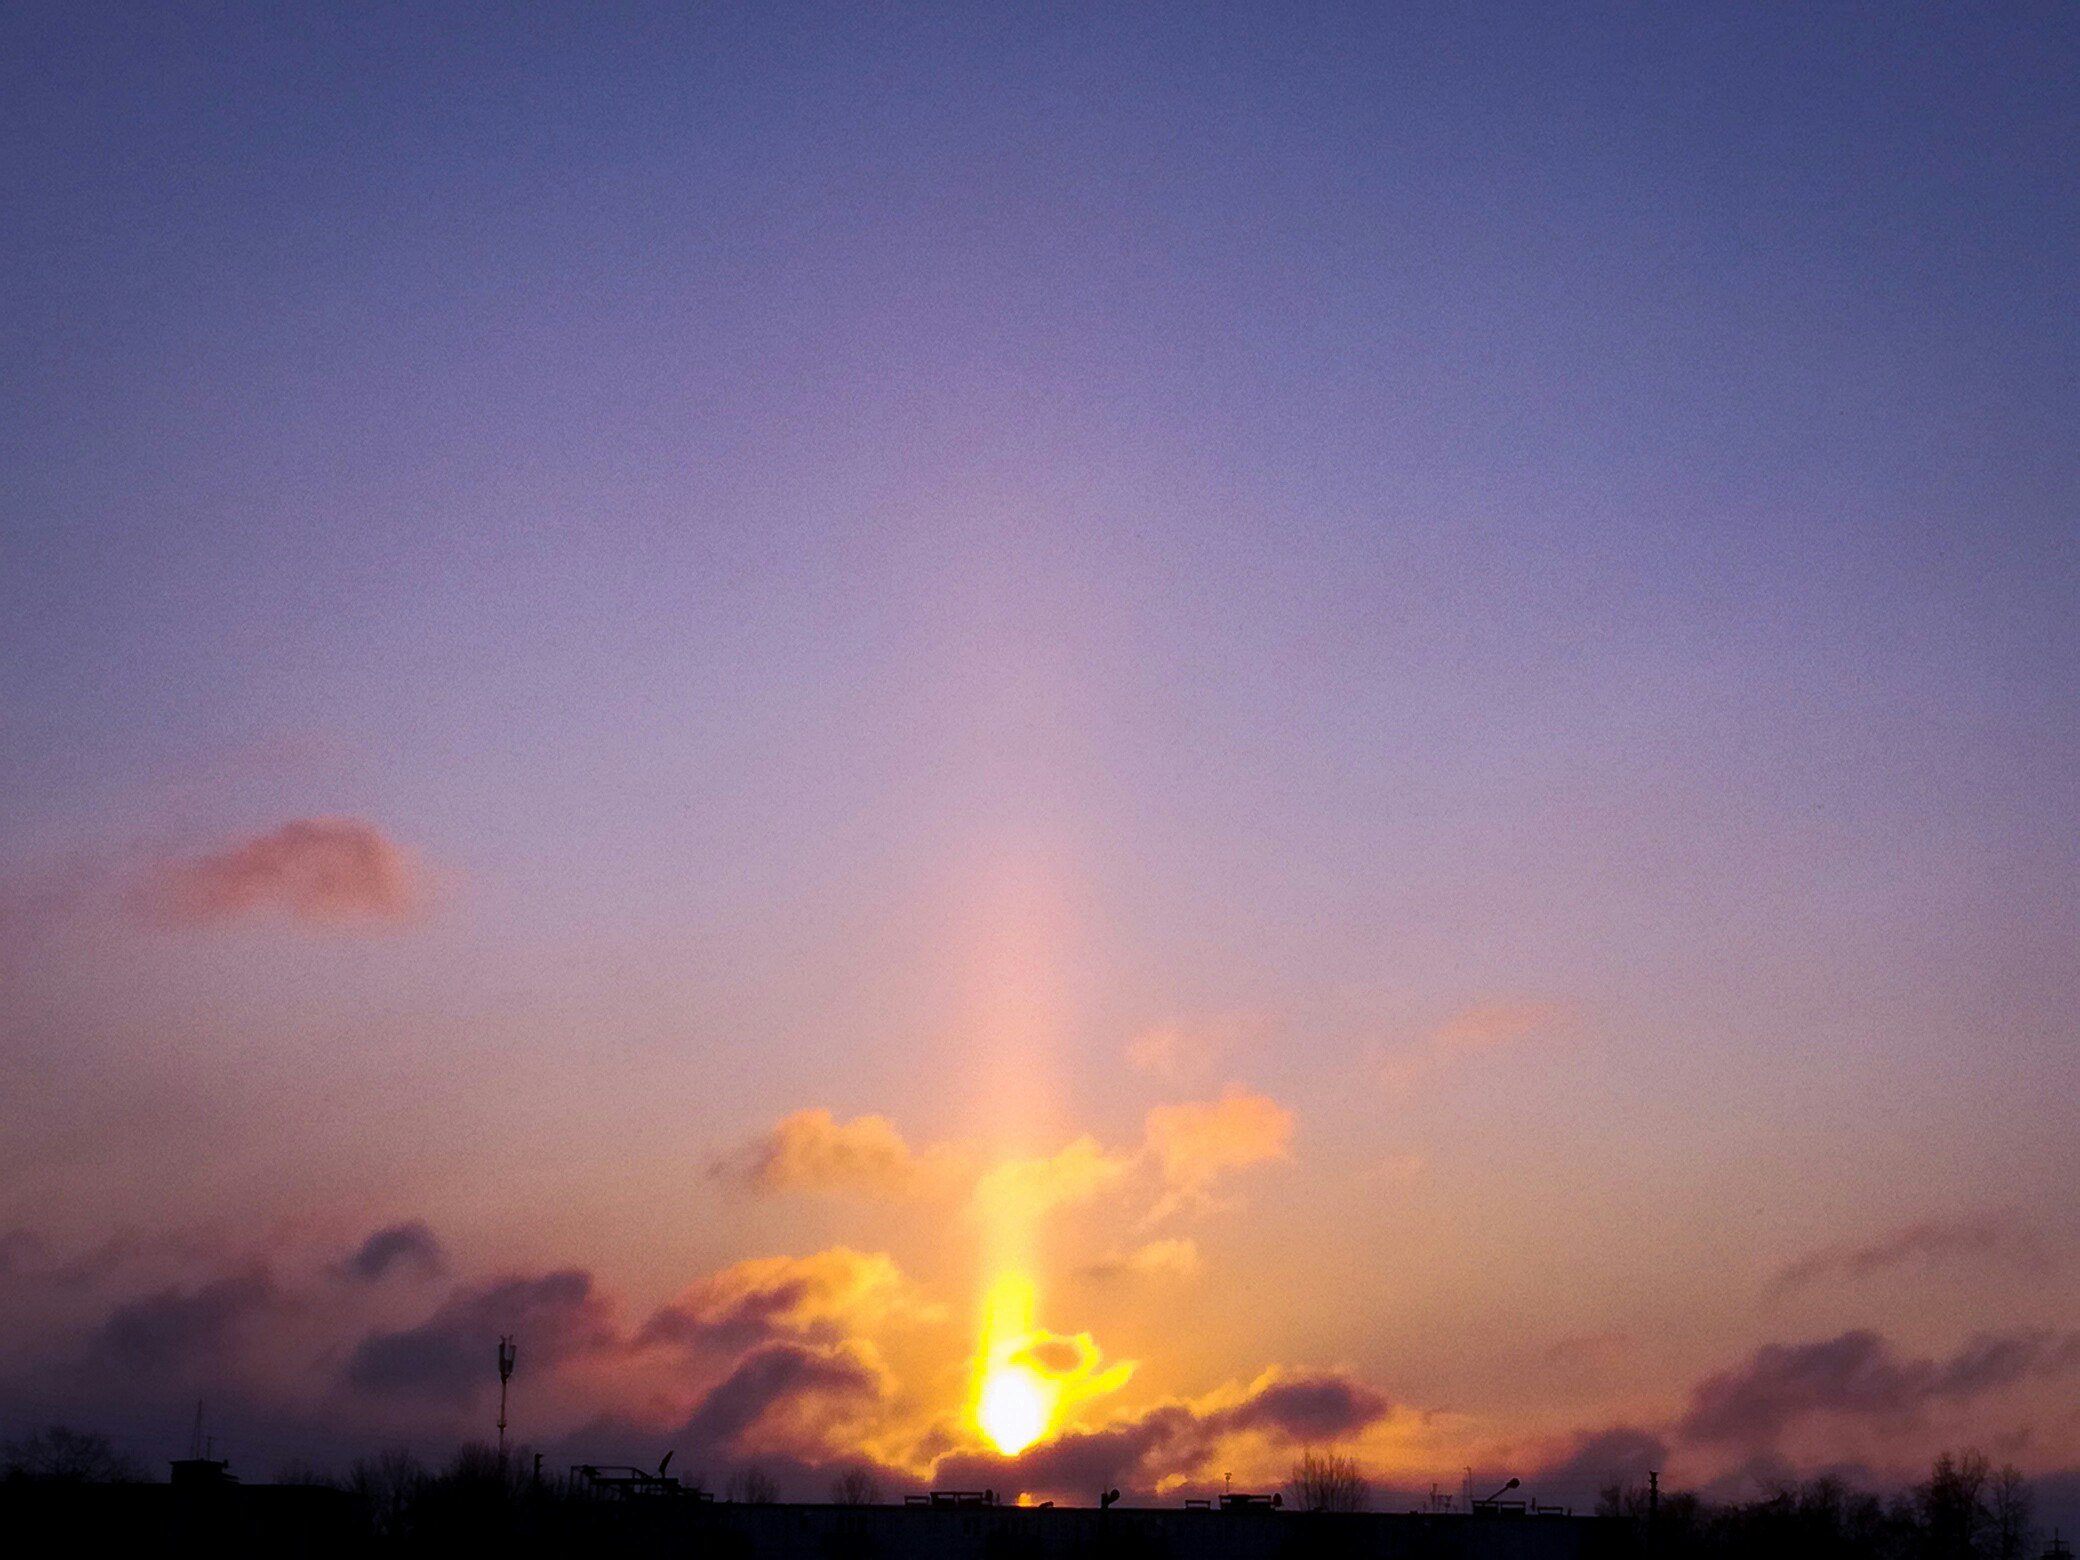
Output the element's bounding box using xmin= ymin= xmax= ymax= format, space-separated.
xmin=0 ymin=1427 xmax=2072 ymax=1560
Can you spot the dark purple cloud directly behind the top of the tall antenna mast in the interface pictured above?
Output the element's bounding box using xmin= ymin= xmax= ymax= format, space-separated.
xmin=347 ymin=1269 xmax=618 ymax=1406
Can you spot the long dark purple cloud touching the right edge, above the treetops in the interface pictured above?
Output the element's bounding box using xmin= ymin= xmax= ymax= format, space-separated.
xmin=1679 ymin=1329 xmax=2080 ymax=1448
